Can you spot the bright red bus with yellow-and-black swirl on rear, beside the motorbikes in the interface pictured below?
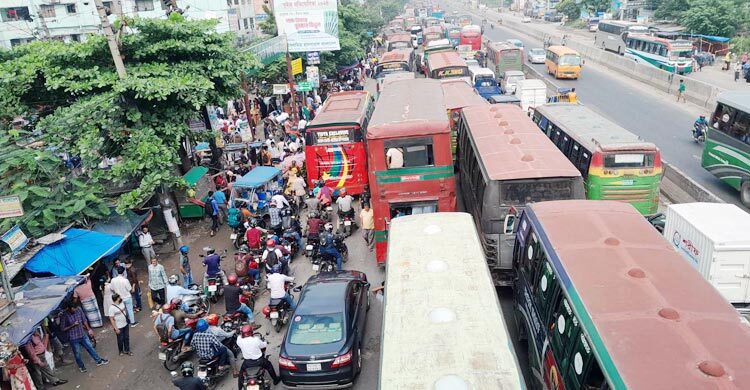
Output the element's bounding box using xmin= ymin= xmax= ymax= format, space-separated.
xmin=305 ymin=91 xmax=374 ymax=195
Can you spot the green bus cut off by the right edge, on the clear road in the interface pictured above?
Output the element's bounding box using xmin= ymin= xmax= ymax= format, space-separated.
xmin=701 ymin=91 xmax=750 ymax=207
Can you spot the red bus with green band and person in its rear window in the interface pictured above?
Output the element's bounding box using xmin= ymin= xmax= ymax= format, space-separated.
xmin=367 ymin=79 xmax=456 ymax=264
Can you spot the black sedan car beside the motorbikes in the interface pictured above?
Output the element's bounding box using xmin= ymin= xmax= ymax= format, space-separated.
xmin=279 ymin=271 xmax=370 ymax=389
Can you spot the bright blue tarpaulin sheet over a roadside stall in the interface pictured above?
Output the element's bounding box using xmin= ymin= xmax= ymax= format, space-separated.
xmin=26 ymin=229 xmax=125 ymax=276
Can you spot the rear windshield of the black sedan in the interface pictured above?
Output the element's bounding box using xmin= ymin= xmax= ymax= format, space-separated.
xmin=289 ymin=313 xmax=344 ymax=345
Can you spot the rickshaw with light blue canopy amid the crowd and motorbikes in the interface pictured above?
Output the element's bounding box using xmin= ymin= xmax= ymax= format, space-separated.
xmin=229 ymin=167 xmax=284 ymax=227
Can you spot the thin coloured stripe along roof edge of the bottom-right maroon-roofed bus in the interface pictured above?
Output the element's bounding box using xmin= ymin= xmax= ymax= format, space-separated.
xmin=526 ymin=209 xmax=627 ymax=390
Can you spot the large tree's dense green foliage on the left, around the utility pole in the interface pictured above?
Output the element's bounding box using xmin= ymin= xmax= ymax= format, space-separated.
xmin=0 ymin=13 xmax=252 ymax=235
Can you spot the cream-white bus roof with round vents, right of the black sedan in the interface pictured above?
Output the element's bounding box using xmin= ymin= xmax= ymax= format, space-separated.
xmin=379 ymin=213 xmax=526 ymax=390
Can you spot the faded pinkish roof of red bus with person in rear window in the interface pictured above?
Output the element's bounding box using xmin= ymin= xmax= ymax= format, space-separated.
xmin=367 ymin=79 xmax=450 ymax=139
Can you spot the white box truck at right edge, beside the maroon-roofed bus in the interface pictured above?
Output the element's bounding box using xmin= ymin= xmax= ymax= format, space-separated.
xmin=664 ymin=203 xmax=750 ymax=310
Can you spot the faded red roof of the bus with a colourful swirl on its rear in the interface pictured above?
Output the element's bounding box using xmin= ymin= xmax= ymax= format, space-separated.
xmin=306 ymin=91 xmax=370 ymax=131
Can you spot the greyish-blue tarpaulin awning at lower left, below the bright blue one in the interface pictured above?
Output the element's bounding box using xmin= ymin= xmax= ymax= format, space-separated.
xmin=0 ymin=276 xmax=84 ymax=346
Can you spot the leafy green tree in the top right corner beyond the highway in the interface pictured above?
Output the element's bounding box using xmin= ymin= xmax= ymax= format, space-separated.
xmin=679 ymin=0 xmax=743 ymax=37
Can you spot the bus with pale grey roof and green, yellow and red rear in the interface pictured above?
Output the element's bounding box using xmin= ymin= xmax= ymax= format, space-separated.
xmin=534 ymin=103 xmax=662 ymax=215
